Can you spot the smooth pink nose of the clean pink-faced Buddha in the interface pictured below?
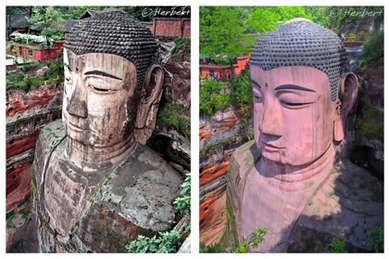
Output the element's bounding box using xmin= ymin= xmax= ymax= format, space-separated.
xmin=260 ymin=102 xmax=284 ymax=137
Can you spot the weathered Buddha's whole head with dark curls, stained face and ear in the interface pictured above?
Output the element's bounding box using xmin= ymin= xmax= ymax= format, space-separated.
xmin=62 ymin=10 xmax=163 ymax=161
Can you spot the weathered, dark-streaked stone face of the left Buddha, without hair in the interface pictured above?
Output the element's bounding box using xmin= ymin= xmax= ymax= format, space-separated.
xmin=62 ymin=49 xmax=139 ymax=148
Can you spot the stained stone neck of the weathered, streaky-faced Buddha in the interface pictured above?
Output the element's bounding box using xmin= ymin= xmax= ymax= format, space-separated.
xmin=66 ymin=134 xmax=137 ymax=171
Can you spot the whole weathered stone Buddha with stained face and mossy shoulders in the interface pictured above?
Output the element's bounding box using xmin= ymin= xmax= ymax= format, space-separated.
xmin=34 ymin=10 xmax=183 ymax=252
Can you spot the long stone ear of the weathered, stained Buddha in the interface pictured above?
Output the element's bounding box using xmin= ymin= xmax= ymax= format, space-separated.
xmin=135 ymin=64 xmax=164 ymax=144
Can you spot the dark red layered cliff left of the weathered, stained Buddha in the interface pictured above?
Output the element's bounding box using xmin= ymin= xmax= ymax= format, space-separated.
xmin=6 ymin=85 xmax=62 ymax=211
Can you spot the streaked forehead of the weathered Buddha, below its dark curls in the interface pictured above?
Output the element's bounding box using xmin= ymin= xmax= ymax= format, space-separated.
xmin=64 ymin=48 xmax=136 ymax=78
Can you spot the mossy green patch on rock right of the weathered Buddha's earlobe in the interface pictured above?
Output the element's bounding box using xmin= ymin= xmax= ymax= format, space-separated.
xmin=158 ymin=103 xmax=190 ymax=136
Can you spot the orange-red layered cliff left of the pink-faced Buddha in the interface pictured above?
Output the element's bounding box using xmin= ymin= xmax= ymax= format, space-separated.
xmin=200 ymin=107 xmax=250 ymax=245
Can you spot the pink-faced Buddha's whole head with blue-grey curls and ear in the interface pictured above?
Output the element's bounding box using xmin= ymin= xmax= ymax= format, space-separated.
xmin=249 ymin=18 xmax=358 ymax=166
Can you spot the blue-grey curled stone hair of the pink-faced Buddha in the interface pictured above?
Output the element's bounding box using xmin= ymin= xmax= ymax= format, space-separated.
xmin=249 ymin=20 xmax=345 ymax=101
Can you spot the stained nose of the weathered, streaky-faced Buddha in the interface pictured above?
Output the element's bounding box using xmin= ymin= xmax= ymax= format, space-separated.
xmin=67 ymin=80 xmax=88 ymax=118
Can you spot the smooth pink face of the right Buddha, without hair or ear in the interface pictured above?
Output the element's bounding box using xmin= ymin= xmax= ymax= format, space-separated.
xmin=250 ymin=65 xmax=336 ymax=166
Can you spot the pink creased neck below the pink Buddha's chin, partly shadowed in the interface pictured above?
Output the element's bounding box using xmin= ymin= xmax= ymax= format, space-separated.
xmin=256 ymin=144 xmax=335 ymax=191
